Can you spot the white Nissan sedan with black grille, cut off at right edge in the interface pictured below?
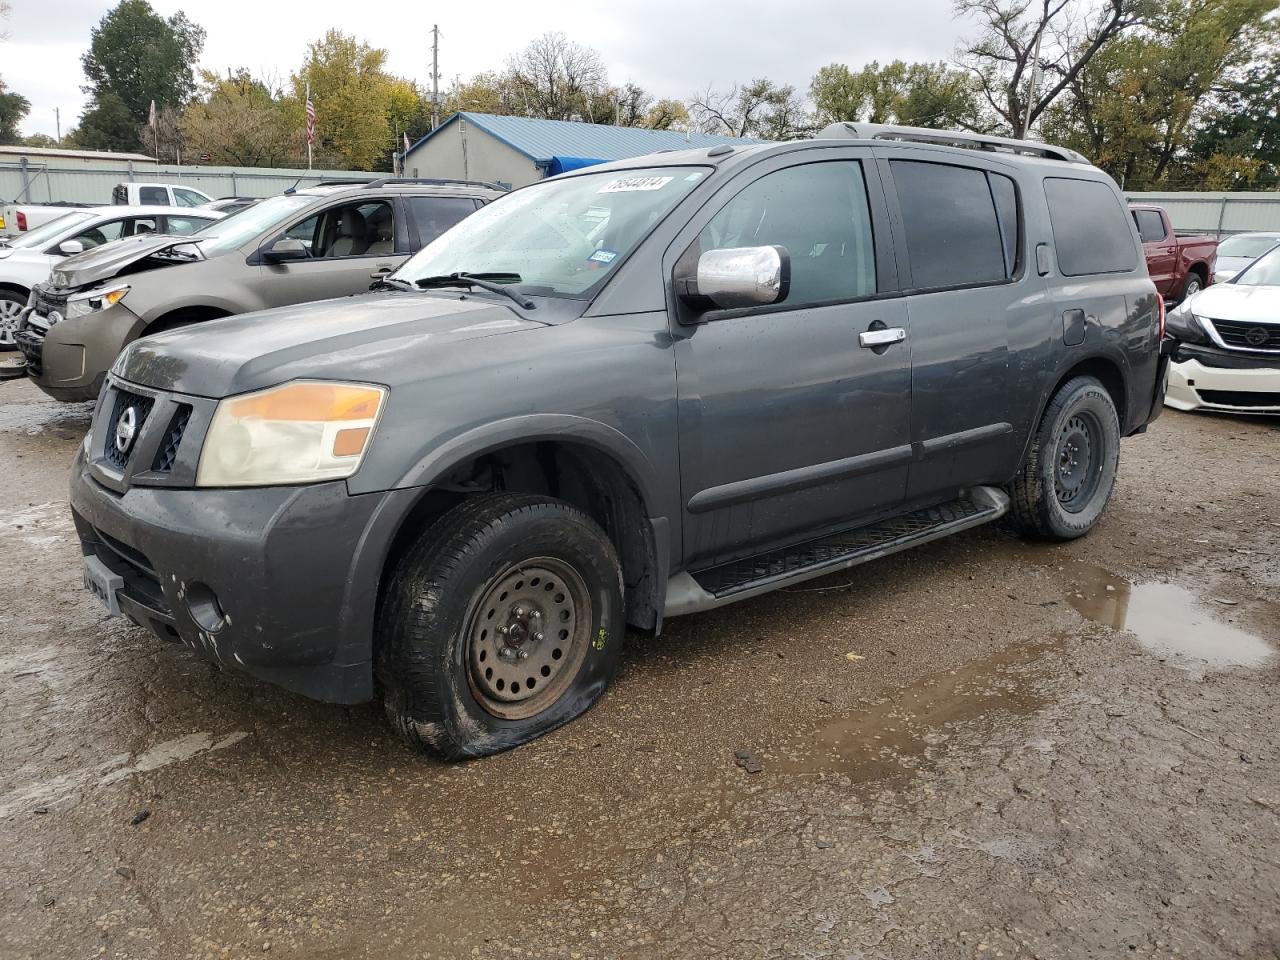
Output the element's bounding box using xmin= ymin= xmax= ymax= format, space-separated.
xmin=1165 ymin=247 xmax=1280 ymax=413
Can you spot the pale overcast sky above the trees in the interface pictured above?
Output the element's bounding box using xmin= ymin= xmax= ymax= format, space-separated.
xmin=0 ymin=0 xmax=964 ymax=136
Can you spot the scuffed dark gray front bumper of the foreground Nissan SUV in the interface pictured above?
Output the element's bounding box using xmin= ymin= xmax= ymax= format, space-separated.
xmin=70 ymin=447 xmax=419 ymax=704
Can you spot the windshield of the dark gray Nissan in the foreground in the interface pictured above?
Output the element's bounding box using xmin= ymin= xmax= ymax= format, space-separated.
xmin=396 ymin=166 xmax=707 ymax=300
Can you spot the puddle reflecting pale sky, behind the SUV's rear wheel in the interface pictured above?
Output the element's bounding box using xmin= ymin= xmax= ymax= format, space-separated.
xmin=1068 ymin=568 xmax=1275 ymax=667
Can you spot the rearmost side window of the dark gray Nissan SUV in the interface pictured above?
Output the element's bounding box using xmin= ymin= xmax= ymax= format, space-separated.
xmin=1044 ymin=177 xmax=1138 ymax=276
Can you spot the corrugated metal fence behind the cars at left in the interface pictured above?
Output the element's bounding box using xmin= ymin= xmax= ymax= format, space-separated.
xmin=0 ymin=159 xmax=378 ymax=204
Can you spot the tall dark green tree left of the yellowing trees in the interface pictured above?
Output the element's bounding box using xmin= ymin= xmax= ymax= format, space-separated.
xmin=78 ymin=0 xmax=205 ymax=150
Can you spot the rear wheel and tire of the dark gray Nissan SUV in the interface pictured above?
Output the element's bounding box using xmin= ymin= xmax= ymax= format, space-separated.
xmin=1009 ymin=376 xmax=1120 ymax=540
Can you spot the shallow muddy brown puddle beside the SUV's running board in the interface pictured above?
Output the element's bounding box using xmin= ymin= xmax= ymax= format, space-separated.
xmin=765 ymin=644 xmax=1048 ymax=782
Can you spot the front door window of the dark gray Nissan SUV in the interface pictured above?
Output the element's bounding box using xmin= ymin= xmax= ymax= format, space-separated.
xmin=695 ymin=160 xmax=876 ymax=306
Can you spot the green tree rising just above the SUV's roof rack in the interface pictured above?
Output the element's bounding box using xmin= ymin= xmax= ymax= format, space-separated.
xmin=809 ymin=60 xmax=989 ymax=131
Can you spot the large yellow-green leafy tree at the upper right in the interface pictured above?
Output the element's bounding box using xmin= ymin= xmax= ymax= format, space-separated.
xmin=1042 ymin=0 xmax=1275 ymax=189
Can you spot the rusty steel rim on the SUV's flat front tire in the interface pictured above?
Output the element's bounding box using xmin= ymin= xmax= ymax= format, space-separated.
xmin=463 ymin=557 xmax=594 ymax=721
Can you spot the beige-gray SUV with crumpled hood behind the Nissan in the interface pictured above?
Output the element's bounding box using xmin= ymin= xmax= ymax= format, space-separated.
xmin=14 ymin=179 xmax=504 ymax=401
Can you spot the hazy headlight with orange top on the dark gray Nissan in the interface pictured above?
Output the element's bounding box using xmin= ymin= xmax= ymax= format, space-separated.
xmin=196 ymin=380 xmax=387 ymax=486
